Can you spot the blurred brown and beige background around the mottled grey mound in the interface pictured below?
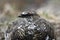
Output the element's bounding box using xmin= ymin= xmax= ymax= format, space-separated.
xmin=0 ymin=0 xmax=60 ymax=40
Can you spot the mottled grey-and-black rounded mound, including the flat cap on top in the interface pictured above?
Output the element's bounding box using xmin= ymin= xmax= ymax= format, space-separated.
xmin=6 ymin=11 xmax=54 ymax=40
